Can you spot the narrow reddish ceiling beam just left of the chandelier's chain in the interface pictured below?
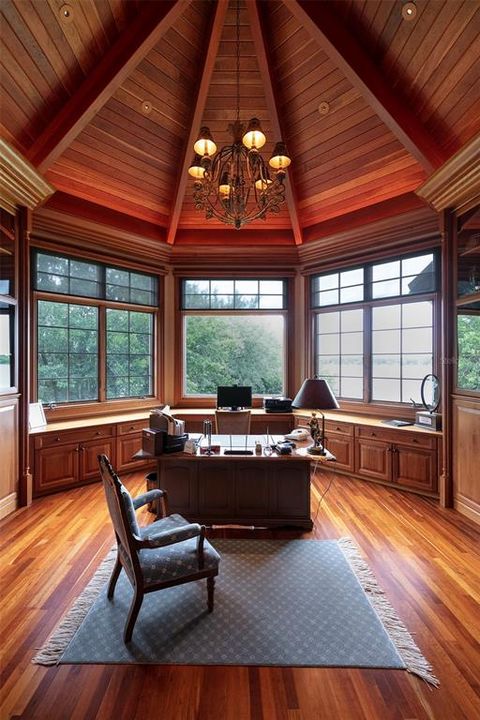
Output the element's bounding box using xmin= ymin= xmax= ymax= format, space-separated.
xmin=167 ymin=0 xmax=228 ymax=245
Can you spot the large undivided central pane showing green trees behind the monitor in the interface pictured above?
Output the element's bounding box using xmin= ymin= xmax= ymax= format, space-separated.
xmin=184 ymin=314 xmax=285 ymax=395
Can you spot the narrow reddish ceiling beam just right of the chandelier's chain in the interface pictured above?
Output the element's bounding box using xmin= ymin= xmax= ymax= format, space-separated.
xmin=247 ymin=0 xmax=303 ymax=245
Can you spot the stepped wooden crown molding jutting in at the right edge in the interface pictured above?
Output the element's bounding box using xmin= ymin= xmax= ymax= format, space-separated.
xmin=415 ymin=134 xmax=480 ymax=215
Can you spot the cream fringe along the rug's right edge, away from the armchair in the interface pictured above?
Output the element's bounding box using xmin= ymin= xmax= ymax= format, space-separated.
xmin=337 ymin=537 xmax=440 ymax=687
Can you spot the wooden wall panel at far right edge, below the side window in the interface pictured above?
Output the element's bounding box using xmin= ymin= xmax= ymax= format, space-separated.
xmin=452 ymin=396 xmax=480 ymax=523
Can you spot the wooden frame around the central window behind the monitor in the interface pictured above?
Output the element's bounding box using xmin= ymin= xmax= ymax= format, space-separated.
xmin=174 ymin=271 xmax=294 ymax=408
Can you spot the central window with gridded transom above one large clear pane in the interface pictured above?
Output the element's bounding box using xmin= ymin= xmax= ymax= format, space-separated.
xmin=181 ymin=279 xmax=286 ymax=396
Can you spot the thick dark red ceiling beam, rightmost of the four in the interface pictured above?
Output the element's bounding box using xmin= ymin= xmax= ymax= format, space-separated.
xmin=288 ymin=0 xmax=448 ymax=173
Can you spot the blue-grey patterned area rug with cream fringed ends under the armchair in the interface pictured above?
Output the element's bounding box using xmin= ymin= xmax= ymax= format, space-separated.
xmin=33 ymin=538 xmax=437 ymax=685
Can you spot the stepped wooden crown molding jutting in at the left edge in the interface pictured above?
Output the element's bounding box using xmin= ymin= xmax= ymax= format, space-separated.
xmin=0 ymin=138 xmax=55 ymax=215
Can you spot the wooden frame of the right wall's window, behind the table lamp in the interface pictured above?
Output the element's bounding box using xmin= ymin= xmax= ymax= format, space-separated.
xmin=306 ymin=247 xmax=441 ymax=417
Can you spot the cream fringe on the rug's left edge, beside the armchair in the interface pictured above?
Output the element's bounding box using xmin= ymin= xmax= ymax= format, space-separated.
xmin=32 ymin=546 xmax=117 ymax=665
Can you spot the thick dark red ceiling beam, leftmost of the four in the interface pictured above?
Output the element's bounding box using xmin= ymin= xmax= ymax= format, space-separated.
xmin=27 ymin=0 xmax=188 ymax=172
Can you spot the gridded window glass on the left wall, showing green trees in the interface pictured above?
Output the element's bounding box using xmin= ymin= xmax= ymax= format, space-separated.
xmin=33 ymin=252 xmax=157 ymax=403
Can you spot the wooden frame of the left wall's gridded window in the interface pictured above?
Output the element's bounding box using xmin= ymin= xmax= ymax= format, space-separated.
xmin=30 ymin=246 xmax=164 ymax=421
